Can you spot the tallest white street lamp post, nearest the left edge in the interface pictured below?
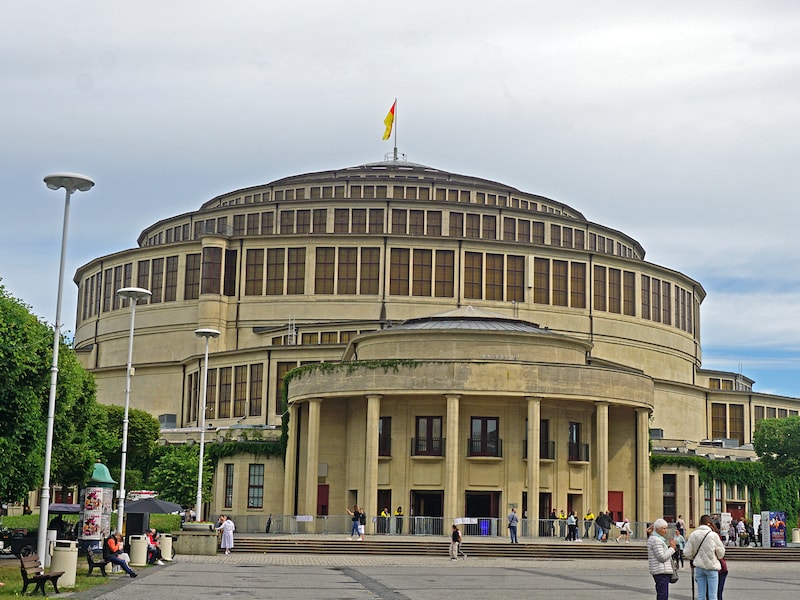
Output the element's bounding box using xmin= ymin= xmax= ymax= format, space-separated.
xmin=37 ymin=173 xmax=94 ymax=556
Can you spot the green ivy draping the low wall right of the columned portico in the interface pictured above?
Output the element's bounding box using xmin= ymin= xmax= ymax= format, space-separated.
xmin=650 ymin=454 xmax=800 ymax=523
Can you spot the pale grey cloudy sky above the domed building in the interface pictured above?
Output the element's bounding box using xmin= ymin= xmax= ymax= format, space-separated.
xmin=0 ymin=0 xmax=800 ymax=396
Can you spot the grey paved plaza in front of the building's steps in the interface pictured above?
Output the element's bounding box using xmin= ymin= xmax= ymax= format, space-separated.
xmin=69 ymin=553 xmax=800 ymax=600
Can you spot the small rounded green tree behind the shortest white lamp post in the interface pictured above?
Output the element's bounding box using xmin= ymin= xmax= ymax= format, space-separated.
xmin=150 ymin=445 xmax=213 ymax=506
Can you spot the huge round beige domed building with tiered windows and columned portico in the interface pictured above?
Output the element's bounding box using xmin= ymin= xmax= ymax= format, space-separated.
xmin=75 ymin=160 xmax=800 ymax=531
